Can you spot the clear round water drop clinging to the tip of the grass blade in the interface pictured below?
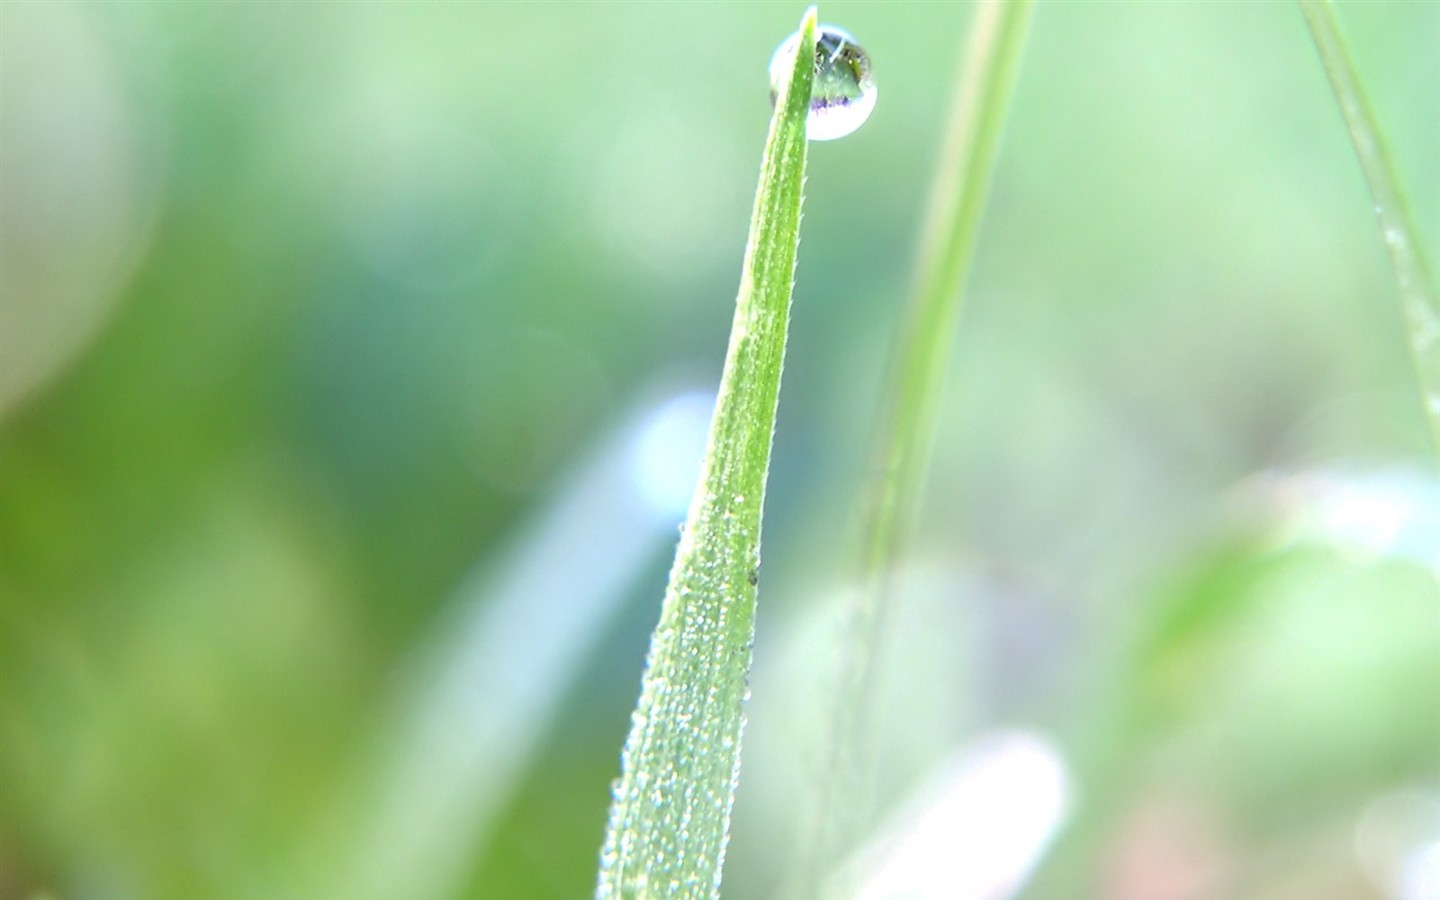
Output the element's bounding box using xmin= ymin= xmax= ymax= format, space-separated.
xmin=770 ymin=24 xmax=876 ymax=141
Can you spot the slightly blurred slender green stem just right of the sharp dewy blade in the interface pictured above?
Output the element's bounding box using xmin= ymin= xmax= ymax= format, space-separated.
xmin=808 ymin=0 xmax=1034 ymax=884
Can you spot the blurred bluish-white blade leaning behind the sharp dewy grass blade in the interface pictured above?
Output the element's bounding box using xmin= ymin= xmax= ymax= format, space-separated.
xmin=333 ymin=392 xmax=714 ymax=900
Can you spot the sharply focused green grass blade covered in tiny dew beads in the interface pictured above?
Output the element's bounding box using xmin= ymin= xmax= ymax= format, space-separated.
xmin=596 ymin=7 xmax=815 ymax=897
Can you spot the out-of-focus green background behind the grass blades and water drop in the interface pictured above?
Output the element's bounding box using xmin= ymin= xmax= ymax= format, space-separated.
xmin=0 ymin=1 xmax=1440 ymax=900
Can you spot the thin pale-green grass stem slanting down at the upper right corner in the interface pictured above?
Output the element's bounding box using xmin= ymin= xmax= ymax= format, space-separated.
xmin=1299 ymin=0 xmax=1440 ymax=452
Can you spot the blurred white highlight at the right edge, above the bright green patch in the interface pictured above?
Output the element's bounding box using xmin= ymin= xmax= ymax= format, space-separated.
xmin=1244 ymin=467 xmax=1440 ymax=570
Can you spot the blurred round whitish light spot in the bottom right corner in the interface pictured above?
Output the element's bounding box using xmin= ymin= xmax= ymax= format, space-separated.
xmin=1355 ymin=788 xmax=1440 ymax=900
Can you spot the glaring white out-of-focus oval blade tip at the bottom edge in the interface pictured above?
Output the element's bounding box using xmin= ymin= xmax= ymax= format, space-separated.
xmin=838 ymin=732 xmax=1068 ymax=900
